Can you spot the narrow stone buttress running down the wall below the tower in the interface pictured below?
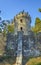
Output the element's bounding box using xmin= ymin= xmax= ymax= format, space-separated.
xmin=16 ymin=31 xmax=22 ymax=65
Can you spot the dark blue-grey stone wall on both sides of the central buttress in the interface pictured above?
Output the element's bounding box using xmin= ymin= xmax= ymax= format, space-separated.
xmin=6 ymin=32 xmax=41 ymax=56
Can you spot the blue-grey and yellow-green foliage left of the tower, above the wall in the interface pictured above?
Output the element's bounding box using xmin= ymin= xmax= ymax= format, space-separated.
xmin=0 ymin=20 xmax=14 ymax=36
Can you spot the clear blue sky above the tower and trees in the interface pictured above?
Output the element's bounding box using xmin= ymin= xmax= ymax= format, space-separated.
xmin=0 ymin=0 xmax=41 ymax=26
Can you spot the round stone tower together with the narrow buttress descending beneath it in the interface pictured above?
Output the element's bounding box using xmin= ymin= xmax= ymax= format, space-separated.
xmin=14 ymin=11 xmax=31 ymax=65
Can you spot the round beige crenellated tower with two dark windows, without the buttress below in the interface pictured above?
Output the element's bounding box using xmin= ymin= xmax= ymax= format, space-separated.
xmin=14 ymin=11 xmax=31 ymax=35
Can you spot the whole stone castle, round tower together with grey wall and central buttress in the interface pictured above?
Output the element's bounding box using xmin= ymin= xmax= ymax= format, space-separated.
xmin=6 ymin=12 xmax=41 ymax=65
